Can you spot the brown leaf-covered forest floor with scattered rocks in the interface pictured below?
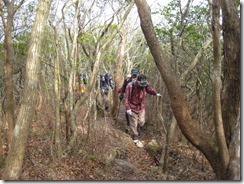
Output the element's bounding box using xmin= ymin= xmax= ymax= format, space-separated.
xmin=0 ymin=103 xmax=215 ymax=181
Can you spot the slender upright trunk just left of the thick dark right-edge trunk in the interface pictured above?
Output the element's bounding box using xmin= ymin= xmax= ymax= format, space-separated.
xmin=212 ymin=0 xmax=229 ymax=178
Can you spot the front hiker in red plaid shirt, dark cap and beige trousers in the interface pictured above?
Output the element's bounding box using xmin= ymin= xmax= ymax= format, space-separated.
xmin=125 ymin=74 xmax=161 ymax=143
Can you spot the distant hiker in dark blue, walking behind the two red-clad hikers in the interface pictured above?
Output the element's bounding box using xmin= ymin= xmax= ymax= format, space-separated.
xmin=100 ymin=73 xmax=115 ymax=111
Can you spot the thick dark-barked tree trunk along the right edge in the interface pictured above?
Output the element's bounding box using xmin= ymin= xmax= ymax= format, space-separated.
xmin=220 ymin=0 xmax=241 ymax=146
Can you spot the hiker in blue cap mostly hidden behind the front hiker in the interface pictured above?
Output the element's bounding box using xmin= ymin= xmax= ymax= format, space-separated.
xmin=118 ymin=69 xmax=138 ymax=126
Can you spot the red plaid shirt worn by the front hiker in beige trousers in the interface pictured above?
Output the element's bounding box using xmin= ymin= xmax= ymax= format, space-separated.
xmin=125 ymin=81 xmax=157 ymax=113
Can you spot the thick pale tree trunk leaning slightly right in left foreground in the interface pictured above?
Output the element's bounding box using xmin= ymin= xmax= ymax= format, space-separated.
xmin=3 ymin=0 xmax=51 ymax=180
